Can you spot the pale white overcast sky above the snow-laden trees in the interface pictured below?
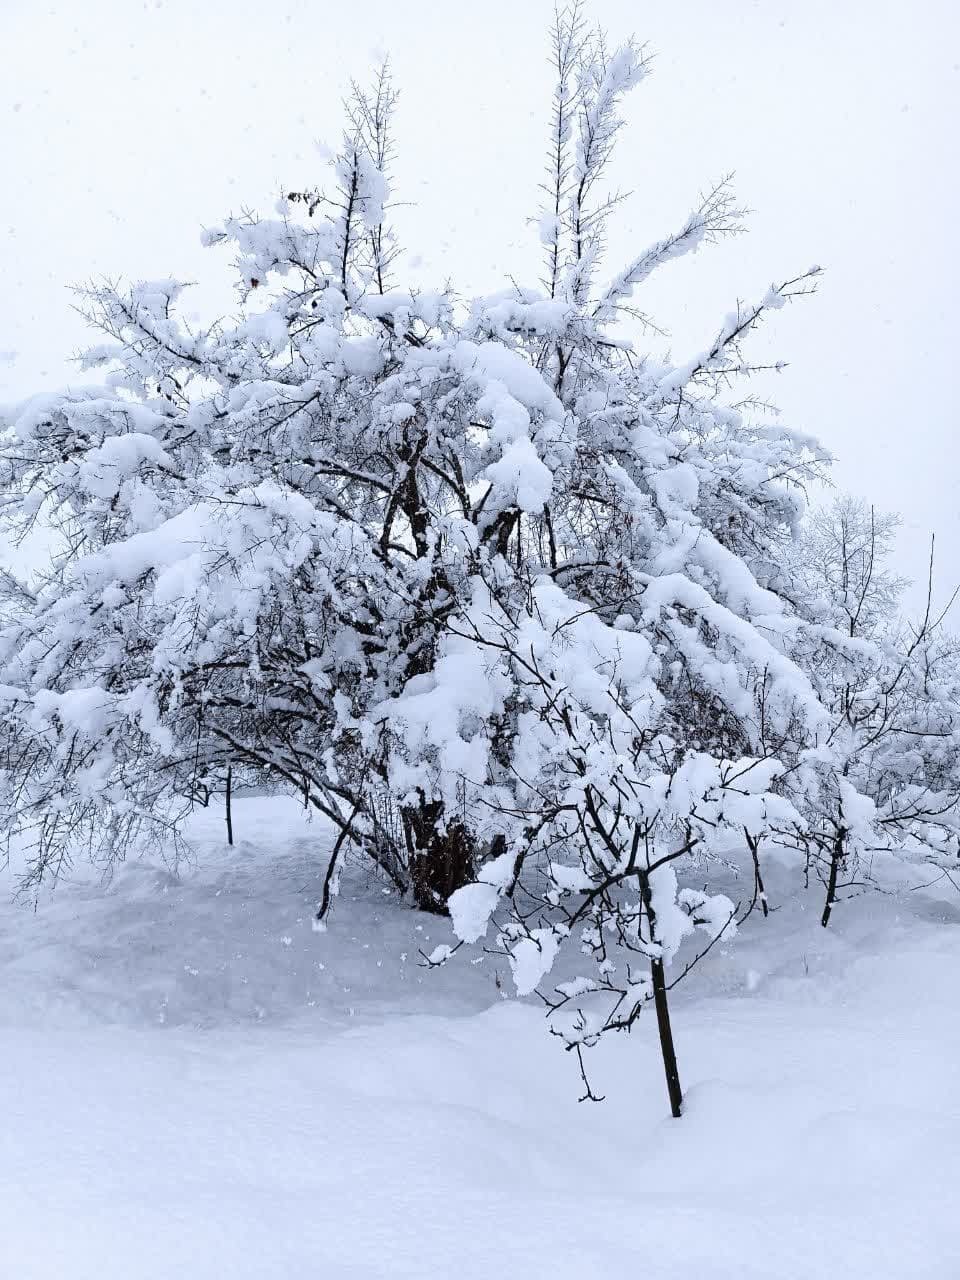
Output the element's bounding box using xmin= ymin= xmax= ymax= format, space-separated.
xmin=0 ymin=0 xmax=960 ymax=604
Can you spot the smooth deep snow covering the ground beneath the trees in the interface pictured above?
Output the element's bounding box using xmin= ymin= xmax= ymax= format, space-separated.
xmin=0 ymin=797 xmax=960 ymax=1280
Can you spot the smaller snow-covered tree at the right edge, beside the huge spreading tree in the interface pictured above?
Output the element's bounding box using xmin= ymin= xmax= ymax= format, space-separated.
xmin=787 ymin=495 xmax=960 ymax=925
